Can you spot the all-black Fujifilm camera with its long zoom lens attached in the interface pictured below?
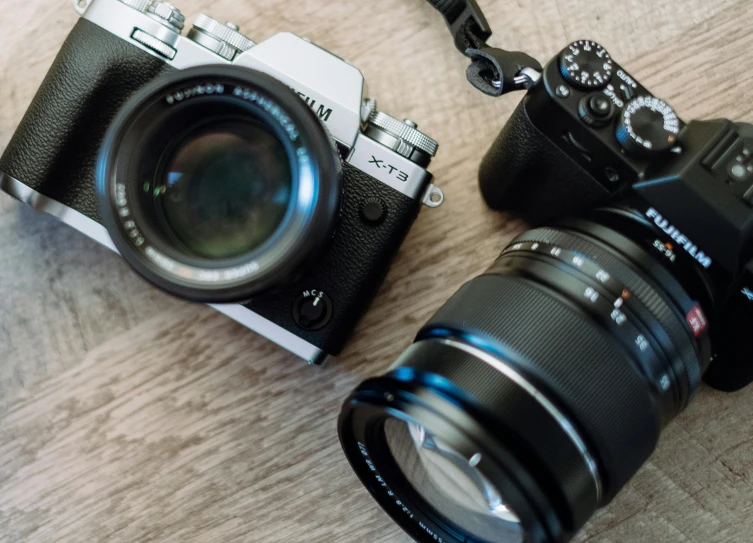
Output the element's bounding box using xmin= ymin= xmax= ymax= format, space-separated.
xmin=340 ymin=40 xmax=753 ymax=543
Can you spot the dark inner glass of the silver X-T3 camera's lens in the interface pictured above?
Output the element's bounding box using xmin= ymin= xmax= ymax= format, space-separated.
xmin=154 ymin=120 xmax=293 ymax=259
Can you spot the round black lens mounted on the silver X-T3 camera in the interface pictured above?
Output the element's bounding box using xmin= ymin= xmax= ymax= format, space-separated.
xmin=97 ymin=66 xmax=342 ymax=303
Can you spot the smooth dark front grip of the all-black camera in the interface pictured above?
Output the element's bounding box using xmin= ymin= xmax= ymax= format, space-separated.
xmin=479 ymin=97 xmax=609 ymax=224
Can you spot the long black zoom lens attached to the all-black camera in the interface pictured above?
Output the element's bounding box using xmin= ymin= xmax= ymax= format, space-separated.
xmin=340 ymin=214 xmax=710 ymax=543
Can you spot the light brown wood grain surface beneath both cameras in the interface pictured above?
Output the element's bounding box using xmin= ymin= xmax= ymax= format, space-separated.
xmin=0 ymin=0 xmax=753 ymax=543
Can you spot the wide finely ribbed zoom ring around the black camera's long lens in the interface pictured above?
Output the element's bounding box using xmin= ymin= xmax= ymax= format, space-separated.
xmin=419 ymin=275 xmax=660 ymax=501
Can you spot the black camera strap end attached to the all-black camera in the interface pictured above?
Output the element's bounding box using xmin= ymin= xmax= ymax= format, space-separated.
xmin=428 ymin=0 xmax=542 ymax=96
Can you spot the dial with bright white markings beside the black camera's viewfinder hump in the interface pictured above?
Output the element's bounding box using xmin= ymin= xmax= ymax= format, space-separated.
xmin=617 ymin=96 xmax=680 ymax=155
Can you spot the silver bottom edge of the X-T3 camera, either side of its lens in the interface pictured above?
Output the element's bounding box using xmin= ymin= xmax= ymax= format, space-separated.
xmin=0 ymin=171 xmax=329 ymax=365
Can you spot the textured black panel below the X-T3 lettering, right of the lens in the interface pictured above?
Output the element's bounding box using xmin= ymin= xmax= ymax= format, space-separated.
xmin=247 ymin=164 xmax=421 ymax=355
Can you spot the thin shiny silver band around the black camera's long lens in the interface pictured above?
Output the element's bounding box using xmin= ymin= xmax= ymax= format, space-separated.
xmin=434 ymin=339 xmax=604 ymax=503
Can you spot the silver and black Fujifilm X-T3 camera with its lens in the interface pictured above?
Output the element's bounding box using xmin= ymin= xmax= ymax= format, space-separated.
xmin=0 ymin=0 xmax=443 ymax=363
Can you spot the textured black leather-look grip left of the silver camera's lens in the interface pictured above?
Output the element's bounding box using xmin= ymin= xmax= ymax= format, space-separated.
xmin=0 ymin=19 xmax=173 ymax=221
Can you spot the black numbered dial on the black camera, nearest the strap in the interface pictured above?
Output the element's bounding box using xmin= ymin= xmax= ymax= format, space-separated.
xmin=560 ymin=40 xmax=614 ymax=89
